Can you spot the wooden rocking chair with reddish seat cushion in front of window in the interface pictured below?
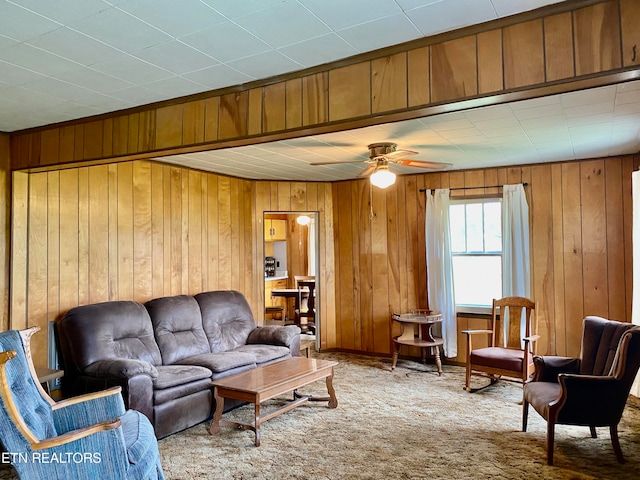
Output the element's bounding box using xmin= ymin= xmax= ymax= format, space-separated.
xmin=462 ymin=297 xmax=540 ymax=392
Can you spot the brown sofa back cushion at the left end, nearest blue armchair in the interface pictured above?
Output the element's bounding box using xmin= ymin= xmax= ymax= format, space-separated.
xmin=58 ymin=301 xmax=162 ymax=371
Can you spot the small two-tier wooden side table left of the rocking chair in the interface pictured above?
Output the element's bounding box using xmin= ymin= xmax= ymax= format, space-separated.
xmin=391 ymin=312 xmax=444 ymax=375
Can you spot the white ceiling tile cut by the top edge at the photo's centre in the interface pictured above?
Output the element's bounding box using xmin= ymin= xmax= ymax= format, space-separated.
xmin=299 ymin=0 xmax=401 ymax=30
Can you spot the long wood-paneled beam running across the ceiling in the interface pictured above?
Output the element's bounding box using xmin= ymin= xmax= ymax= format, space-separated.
xmin=10 ymin=0 xmax=640 ymax=170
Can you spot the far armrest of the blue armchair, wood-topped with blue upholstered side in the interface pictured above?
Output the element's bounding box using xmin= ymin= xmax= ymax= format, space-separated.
xmin=51 ymin=387 xmax=125 ymax=432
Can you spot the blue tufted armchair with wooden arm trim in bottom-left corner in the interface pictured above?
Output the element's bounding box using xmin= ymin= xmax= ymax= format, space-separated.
xmin=0 ymin=328 xmax=164 ymax=480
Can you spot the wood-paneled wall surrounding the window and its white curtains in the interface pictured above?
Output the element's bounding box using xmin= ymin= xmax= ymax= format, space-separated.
xmin=333 ymin=156 xmax=640 ymax=362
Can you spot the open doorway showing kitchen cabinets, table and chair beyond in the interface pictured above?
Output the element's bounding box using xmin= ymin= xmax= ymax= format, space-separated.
xmin=263 ymin=211 xmax=321 ymax=347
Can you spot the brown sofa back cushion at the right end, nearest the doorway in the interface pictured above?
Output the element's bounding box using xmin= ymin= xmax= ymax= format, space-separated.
xmin=195 ymin=290 xmax=256 ymax=353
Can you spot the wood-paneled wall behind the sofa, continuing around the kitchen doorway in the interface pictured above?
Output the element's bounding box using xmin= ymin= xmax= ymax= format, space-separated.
xmin=11 ymin=161 xmax=335 ymax=365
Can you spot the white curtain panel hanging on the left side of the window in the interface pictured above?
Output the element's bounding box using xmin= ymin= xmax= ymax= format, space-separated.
xmin=425 ymin=189 xmax=458 ymax=358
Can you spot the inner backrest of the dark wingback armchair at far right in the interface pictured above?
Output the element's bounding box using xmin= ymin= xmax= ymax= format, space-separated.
xmin=580 ymin=316 xmax=634 ymax=375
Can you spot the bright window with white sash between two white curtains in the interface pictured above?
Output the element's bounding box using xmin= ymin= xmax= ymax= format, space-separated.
xmin=449 ymin=198 xmax=502 ymax=312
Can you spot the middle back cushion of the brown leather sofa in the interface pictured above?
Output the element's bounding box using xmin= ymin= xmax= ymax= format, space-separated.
xmin=144 ymin=295 xmax=209 ymax=365
